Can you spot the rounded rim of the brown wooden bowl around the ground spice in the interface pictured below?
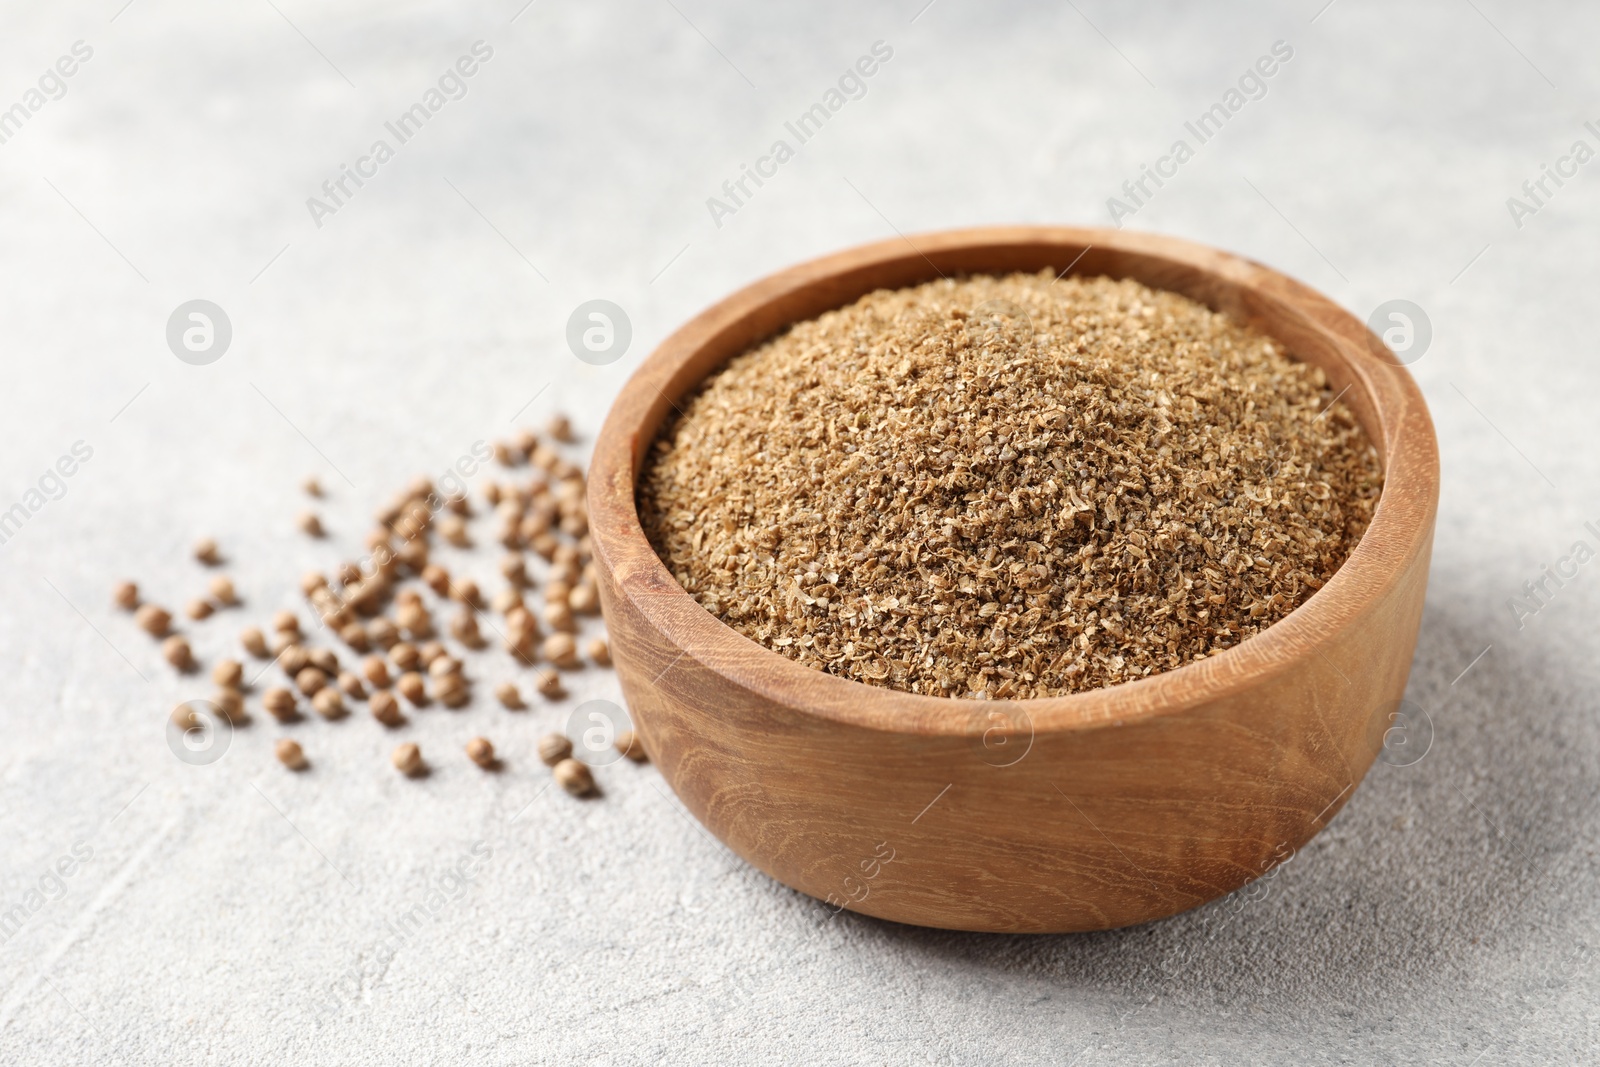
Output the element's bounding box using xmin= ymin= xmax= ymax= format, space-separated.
xmin=589 ymin=226 xmax=1440 ymax=737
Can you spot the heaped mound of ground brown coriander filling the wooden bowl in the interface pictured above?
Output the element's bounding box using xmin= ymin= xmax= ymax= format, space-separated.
xmin=638 ymin=270 xmax=1382 ymax=699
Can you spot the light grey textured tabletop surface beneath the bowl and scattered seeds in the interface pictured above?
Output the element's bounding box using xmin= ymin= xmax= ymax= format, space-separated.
xmin=0 ymin=0 xmax=1600 ymax=1064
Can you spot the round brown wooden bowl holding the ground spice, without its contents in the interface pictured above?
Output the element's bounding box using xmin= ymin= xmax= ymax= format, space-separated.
xmin=589 ymin=227 xmax=1438 ymax=931
